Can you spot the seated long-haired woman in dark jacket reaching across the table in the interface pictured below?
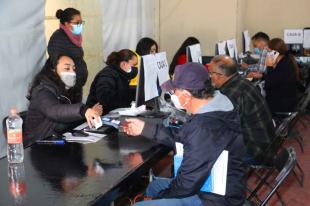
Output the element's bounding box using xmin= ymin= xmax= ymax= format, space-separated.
xmin=25 ymin=55 xmax=102 ymax=141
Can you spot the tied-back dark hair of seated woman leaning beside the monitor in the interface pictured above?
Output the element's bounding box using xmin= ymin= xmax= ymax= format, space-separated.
xmin=106 ymin=49 xmax=137 ymax=67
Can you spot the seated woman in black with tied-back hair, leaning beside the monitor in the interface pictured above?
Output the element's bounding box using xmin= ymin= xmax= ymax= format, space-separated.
xmin=86 ymin=49 xmax=138 ymax=114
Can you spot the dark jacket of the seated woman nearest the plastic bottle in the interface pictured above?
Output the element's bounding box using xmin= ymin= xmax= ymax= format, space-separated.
xmin=25 ymin=78 xmax=87 ymax=140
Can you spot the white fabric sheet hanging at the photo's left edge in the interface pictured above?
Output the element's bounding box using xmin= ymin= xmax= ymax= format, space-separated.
xmin=0 ymin=0 xmax=45 ymax=156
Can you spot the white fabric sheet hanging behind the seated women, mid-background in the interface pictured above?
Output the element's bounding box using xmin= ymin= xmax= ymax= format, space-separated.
xmin=101 ymin=0 xmax=156 ymax=59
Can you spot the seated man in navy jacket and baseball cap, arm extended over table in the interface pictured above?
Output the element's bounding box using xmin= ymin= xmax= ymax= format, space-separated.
xmin=124 ymin=63 xmax=245 ymax=206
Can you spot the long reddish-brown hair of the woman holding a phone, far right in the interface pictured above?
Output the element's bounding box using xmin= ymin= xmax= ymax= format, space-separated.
xmin=268 ymin=38 xmax=300 ymax=80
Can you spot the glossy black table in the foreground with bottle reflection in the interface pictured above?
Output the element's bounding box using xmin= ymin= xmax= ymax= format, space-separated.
xmin=0 ymin=132 xmax=169 ymax=206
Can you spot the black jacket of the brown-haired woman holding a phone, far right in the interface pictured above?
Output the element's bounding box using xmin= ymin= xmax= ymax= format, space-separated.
xmin=265 ymin=56 xmax=297 ymax=112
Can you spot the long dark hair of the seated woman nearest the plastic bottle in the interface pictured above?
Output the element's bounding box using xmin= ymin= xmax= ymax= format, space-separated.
xmin=27 ymin=54 xmax=72 ymax=100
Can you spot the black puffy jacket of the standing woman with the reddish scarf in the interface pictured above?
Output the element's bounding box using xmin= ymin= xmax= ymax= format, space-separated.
xmin=47 ymin=29 xmax=88 ymax=102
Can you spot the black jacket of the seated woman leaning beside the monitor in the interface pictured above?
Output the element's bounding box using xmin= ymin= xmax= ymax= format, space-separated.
xmin=86 ymin=66 xmax=137 ymax=114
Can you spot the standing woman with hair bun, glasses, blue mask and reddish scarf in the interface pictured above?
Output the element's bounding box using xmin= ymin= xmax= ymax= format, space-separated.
xmin=47 ymin=8 xmax=88 ymax=103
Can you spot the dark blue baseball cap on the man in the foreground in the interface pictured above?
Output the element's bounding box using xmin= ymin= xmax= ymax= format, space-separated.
xmin=162 ymin=62 xmax=211 ymax=91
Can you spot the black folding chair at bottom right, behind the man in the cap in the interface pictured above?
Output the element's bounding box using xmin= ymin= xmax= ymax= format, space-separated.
xmin=244 ymin=148 xmax=296 ymax=206
